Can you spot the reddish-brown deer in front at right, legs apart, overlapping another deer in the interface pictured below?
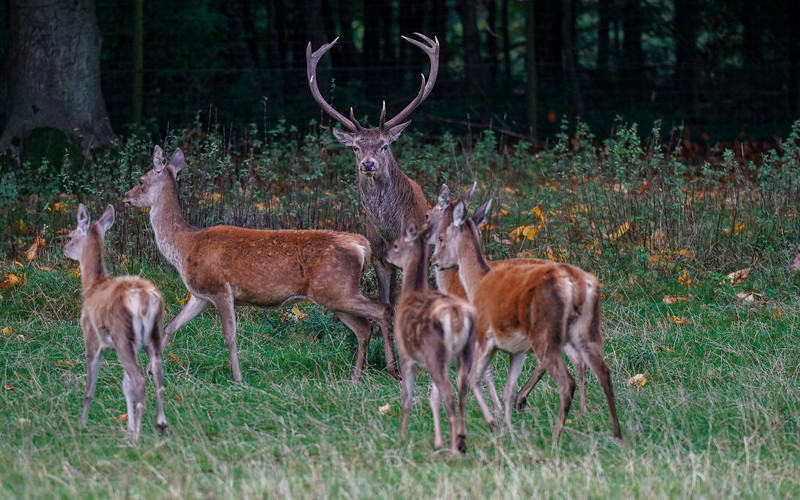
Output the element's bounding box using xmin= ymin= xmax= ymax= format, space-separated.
xmin=433 ymin=200 xmax=622 ymax=441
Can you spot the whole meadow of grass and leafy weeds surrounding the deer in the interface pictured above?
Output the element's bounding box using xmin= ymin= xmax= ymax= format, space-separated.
xmin=0 ymin=119 xmax=800 ymax=498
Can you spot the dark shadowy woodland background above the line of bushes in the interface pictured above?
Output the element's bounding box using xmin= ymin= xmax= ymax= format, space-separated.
xmin=0 ymin=0 xmax=800 ymax=150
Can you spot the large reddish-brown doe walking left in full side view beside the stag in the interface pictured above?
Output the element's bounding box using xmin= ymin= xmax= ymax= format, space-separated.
xmin=122 ymin=146 xmax=397 ymax=382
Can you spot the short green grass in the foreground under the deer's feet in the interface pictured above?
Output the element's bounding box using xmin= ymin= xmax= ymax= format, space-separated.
xmin=0 ymin=256 xmax=800 ymax=498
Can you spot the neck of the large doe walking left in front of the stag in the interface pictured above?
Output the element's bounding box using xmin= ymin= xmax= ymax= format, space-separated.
xmin=150 ymin=179 xmax=195 ymax=270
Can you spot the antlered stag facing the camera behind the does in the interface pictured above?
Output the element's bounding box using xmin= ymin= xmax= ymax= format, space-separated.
xmin=306 ymin=33 xmax=439 ymax=304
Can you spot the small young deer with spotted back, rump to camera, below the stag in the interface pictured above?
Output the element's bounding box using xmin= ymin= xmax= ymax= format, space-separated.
xmin=386 ymin=223 xmax=476 ymax=453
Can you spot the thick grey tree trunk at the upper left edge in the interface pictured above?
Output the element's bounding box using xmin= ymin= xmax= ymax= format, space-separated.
xmin=0 ymin=0 xmax=115 ymax=154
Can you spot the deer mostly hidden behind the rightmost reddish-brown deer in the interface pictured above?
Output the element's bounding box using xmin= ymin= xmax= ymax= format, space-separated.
xmin=428 ymin=183 xmax=600 ymax=415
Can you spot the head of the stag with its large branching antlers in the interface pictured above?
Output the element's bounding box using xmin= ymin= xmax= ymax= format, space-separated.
xmin=306 ymin=33 xmax=439 ymax=177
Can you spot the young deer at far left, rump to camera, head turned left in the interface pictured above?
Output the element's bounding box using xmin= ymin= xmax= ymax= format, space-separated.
xmin=63 ymin=204 xmax=167 ymax=439
